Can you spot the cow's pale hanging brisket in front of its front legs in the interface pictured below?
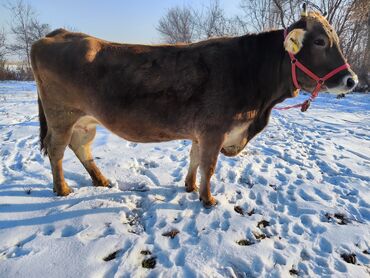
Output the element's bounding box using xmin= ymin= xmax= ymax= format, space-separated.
xmin=221 ymin=122 xmax=251 ymax=156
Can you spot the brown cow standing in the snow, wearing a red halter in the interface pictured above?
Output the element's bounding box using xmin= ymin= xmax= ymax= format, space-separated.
xmin=31 ymin=8 xmax=357 ymax=208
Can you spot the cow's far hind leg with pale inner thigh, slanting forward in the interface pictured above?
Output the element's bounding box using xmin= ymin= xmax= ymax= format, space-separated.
xmin=69 ymin=118 xmax=109 ymax=186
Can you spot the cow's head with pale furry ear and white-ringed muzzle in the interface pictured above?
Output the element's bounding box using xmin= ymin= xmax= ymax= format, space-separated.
xmin=284 ymin=6 xmax=358 ymax=94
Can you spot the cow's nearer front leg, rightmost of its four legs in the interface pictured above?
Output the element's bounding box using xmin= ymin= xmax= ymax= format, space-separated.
xmin=199 ymin=135 xmax=224 ymax=208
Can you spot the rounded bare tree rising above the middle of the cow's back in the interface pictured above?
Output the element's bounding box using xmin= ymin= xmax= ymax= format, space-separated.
xmin=157 ymin=6 xmax=195 ymax=43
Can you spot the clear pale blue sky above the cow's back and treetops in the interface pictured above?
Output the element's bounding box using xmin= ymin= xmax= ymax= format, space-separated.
xmin=0 ymin=0 xmax=240 ymax=44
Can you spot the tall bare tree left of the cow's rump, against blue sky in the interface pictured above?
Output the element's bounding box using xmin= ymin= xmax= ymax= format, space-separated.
xmin=6 ymin=0 xmax=50 ymax=69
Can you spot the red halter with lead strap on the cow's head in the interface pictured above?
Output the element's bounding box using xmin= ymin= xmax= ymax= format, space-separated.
xmin=274 ymin=29 xmax=350 ymax=112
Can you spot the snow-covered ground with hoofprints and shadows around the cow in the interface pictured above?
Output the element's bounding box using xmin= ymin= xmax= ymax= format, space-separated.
xmin=0 ymin=82 xmax=370 ymax=278
